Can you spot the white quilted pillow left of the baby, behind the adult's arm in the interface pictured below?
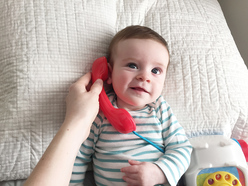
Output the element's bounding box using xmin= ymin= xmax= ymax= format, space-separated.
xmin=0 ymin=0 xmax=116 ymax=181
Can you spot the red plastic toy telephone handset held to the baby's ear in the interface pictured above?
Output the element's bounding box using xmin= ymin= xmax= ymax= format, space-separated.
xmin=92 ymin=57 xmax=136 ymax=134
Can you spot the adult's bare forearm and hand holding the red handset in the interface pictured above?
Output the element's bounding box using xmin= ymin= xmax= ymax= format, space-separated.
xmin=24 ymin=73 xmax=103 ymax=186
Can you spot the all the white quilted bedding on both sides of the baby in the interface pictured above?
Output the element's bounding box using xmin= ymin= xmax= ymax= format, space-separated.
xmin=0 ymin=0 xmax=248 ymax=181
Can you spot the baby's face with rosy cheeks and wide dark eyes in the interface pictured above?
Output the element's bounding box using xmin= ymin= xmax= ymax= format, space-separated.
xmin=110 ymin=39 xmax=169 ymax=110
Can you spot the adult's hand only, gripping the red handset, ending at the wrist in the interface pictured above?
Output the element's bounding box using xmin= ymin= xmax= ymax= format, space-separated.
xmin=65 ymin=73 xmax=103 ymax=137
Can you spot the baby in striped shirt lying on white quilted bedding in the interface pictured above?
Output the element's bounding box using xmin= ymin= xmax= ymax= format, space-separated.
xmin=70 ymin=26 xmax=192 ymax=186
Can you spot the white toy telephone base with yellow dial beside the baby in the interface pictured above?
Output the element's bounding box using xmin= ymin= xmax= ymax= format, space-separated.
xmin=185 ymin=135 xmax=248 ymax=186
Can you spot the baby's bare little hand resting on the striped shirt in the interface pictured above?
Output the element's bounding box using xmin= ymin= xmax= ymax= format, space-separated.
xmin=121 ymin=160 xmax=167 ymax=186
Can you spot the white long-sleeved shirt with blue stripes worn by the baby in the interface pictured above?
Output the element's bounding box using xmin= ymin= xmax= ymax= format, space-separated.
xmin=70 ymin=94 xmax=192 ymax=186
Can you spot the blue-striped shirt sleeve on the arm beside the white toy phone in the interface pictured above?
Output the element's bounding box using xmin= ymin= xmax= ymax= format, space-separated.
xmin=155 ymin=96 xmax=192 ymax=186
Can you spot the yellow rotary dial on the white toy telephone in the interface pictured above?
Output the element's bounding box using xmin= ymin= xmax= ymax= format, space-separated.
xmin=203 ymin=171 xmax=242 ymax=186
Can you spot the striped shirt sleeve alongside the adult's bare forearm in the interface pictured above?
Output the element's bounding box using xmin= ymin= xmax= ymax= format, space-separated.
xmin=69 ymin=115 xmax=102 ymax=186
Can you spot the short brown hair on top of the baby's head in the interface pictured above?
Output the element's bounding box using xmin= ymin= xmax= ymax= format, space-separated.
xmin=107 ymin=25 xmax=169 ymax=65
